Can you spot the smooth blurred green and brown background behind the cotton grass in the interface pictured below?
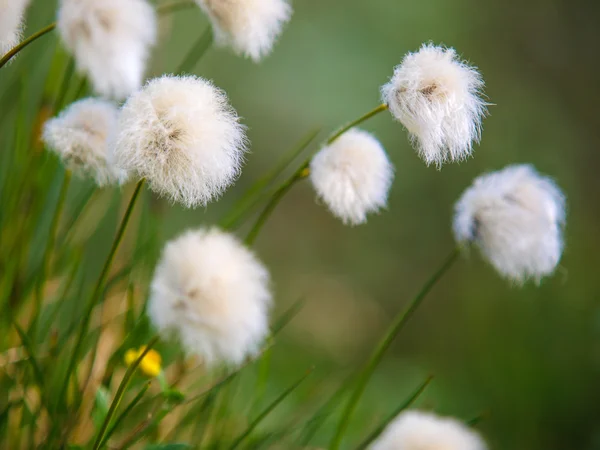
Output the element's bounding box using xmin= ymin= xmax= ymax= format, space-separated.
xmin=0 ymin=0 xmax=600 ymax=450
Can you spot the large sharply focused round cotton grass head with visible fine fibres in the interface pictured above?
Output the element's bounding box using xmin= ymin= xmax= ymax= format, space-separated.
xmin=113 ymin=76 xmax=246 ymax=207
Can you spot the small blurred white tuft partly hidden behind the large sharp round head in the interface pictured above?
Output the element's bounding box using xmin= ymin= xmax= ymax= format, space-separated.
xmin=42 ymin=98 xmax=123 ymax=186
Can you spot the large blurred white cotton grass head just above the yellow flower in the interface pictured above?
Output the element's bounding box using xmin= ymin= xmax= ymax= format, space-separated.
xmin=148 ymin=228 xmax=271 ymax=365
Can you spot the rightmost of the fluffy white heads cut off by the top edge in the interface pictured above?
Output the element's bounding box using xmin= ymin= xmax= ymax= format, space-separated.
xmin=196 ymin=0 xmax=292 ymax=62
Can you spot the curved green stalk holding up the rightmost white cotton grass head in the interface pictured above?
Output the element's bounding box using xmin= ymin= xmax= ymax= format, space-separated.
xmin=329 ymin=248 xmax=460 ymax=450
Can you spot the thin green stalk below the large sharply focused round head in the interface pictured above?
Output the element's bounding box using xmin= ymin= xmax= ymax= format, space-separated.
xmin=58 ymin=178 xmax=145 ymax=408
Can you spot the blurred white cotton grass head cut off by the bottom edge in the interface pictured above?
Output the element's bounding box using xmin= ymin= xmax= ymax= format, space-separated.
xmin=369 ymin=411 xmax=487 ymax=450
